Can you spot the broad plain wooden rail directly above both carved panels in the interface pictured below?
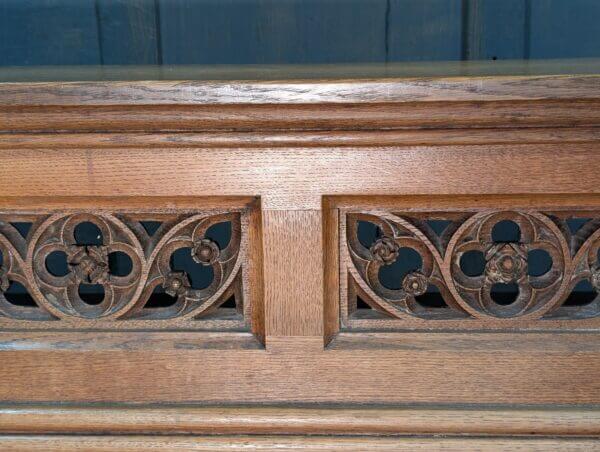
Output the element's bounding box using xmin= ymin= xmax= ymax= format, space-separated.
xmin=0 ymin=145 xmax=600 ymax=210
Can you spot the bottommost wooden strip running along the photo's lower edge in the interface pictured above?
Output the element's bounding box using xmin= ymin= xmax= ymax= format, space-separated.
xmin=0 ymin=435 xmax=600 ymax=452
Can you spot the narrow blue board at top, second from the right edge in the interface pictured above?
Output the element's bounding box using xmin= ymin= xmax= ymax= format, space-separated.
xmin=464 ymin=0 xmax=528 ymax=60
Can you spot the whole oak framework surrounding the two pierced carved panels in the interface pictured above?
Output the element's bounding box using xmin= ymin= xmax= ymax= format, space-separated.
xmin=0 ymin=68 xmax=600 ymax=450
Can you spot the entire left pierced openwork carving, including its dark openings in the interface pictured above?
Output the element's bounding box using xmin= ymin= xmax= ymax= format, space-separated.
xmin=0 ymin=211 xmax=249 ymax=328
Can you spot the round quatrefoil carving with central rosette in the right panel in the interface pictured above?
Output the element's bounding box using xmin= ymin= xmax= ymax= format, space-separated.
xmin=447 ymin=212 xmax=568 ymax=318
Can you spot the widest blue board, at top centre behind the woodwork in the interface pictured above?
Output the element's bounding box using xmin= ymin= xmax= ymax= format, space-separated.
xmin=159 ymin=0 xmax=386 ymax=64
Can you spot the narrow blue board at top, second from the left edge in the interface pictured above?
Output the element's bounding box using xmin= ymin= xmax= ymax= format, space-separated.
xmin=96 ymin=0 xmax=160 ymax=64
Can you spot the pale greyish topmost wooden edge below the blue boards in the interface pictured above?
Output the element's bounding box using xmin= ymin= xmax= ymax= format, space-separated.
xmin=0 ymin=74 xmax=600 ymax=107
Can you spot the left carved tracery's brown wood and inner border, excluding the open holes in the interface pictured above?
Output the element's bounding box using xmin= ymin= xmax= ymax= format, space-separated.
xmin=0 ymin=199 xmax=264 ymax=338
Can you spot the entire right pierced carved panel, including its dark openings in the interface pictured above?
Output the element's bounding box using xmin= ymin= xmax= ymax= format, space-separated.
xmin=340 ymin=210 xmax=600 ymax=329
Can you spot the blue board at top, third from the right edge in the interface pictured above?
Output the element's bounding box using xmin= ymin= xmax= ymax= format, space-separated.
xmin=388 ymin=0 xmax=463 ymax=61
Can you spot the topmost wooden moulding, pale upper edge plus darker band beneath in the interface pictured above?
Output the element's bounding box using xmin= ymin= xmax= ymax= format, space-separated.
xmin=0 ymin=75 xmax=600 ymax=133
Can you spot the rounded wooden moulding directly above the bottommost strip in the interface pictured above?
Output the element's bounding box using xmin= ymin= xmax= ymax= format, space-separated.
xmin=0 ymin=405 xmax=600 ymax=437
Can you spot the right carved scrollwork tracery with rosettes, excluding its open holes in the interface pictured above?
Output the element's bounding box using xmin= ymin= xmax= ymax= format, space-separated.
xmin=345 ymin=211 xmax=600 ymax=321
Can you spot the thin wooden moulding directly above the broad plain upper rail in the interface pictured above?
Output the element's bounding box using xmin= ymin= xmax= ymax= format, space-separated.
xmin=0 ymin=127 xmax=600 ymax=150
